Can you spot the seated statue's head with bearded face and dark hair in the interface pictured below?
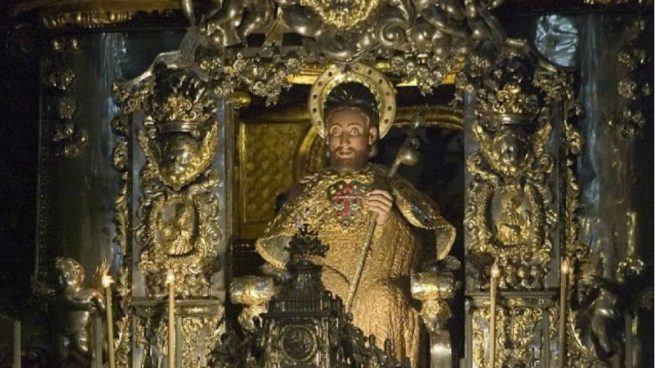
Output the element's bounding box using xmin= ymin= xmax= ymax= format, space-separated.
xmin=324 ymin=82 xmax=379 ymax=172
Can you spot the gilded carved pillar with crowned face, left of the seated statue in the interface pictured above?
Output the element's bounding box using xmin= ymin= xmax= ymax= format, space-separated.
xmin=112 ymin=64 xmax=228 ymax=366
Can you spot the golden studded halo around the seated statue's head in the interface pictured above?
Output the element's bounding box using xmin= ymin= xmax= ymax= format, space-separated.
xmin=308 ymin=63 xmax=396 ymax=138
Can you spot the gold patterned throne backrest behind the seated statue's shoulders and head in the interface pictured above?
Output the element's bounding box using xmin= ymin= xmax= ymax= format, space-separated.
xmin=235 ymin=104 xmax=462 ymax=240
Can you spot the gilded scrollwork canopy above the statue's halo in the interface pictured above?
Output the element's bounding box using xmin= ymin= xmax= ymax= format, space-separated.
xmin=184 ymin=0 xmax=510 ymax=103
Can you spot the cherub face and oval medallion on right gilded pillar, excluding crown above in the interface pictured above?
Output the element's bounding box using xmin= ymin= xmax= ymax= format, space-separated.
xmin=466 ymin=116 xmax=556 ymax=289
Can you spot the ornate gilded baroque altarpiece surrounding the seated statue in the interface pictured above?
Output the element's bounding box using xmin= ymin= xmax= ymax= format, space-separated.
xmin=9 ymin=0 xmax=652 ymax=367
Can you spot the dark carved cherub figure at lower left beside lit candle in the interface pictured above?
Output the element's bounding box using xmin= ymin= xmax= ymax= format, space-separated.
xmin=54 ymin=257 xmax=105 ymax=367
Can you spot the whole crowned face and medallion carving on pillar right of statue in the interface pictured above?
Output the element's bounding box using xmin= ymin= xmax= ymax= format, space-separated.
xmin=465 ymin=43 xmax=556 ymax=290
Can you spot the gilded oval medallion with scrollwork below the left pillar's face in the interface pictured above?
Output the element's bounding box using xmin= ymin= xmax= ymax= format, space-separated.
xmin=139 ymin=170 xmax=219 ymax=297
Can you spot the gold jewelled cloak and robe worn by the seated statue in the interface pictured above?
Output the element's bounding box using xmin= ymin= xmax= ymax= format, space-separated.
xmin=256 ymin=165 xmax=455 ymax=366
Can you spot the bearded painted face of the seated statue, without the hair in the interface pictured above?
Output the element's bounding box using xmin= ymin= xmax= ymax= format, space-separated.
xmin=327 ymin=109 xmax=378 ymax=172
